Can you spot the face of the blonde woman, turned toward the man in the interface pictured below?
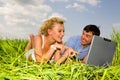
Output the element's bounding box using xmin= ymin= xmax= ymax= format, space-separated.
xmin=50 ymin=23 xmax=64 ymax=42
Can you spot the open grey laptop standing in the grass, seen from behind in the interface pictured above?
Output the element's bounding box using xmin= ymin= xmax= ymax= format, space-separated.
xmin=86 ymin=36 xmax=117 ymax=66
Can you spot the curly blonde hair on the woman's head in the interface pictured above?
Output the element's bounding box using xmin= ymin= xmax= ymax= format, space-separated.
xmin=39 ymin=17 xmax=65 ymax=36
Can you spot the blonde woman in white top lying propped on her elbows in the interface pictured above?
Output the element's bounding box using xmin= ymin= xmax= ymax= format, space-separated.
xmin=25 ymin=17 xmax=75 ymax=63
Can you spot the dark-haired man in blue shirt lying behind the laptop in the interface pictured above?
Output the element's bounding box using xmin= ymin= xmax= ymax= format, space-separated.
xmin=66 ymin=24 xmax=100 ymax=63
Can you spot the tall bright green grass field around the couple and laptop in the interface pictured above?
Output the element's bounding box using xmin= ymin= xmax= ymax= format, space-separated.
xmin=0 ymin=32 xmax=120 ymax=80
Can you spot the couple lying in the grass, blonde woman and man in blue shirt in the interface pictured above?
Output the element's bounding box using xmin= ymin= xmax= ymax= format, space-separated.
xmin=25 ymin=17 xmax=100 ymax=63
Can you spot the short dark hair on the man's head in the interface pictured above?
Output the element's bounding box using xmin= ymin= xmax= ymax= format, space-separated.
xmin=83 ymin=24 xmax=100 ymax=36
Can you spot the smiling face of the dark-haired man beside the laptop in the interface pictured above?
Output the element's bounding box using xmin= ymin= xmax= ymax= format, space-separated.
xmin=81 ymin=31 xmax=93 ymax=46
